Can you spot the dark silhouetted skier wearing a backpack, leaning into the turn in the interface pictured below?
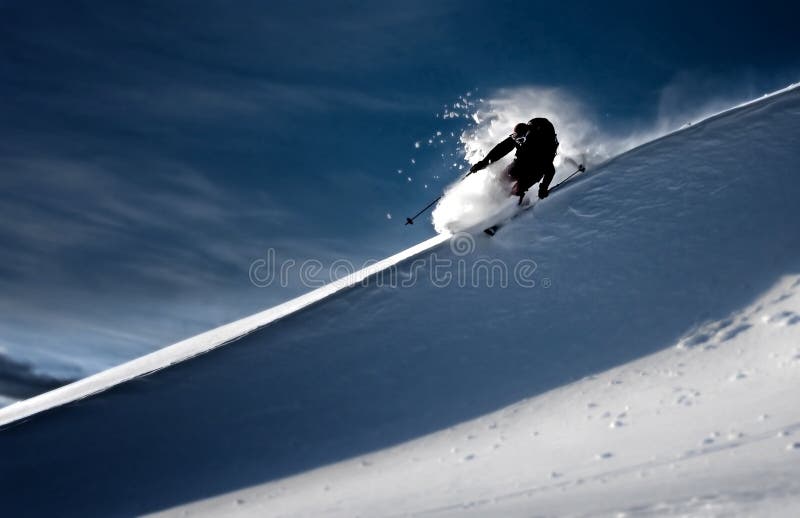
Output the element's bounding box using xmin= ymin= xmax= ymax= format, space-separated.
xmin=469 ymin=117 xmax=558 ymax=204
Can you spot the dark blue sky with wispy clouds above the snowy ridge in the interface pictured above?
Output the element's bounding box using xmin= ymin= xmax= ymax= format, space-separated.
xmin=0 ymin=0 xmax=800 ymax=384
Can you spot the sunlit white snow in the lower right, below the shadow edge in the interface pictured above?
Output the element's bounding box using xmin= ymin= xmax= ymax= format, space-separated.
xmin=170 ymin=275 xmax=800 ymax=517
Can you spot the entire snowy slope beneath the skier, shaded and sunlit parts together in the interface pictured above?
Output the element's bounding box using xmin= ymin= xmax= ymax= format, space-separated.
xmin=0 ymin=83 xmax=800 ymax=516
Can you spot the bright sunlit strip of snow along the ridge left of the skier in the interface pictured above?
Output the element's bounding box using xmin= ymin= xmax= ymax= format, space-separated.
xmin=0 ymin=234 xmax=450 ymax=429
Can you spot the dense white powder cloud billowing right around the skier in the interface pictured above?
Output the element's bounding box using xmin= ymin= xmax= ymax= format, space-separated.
xmin=433 ymin=87 xmax=608 ymax=232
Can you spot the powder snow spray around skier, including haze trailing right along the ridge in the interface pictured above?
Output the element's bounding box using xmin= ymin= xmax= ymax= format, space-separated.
xmin=432 ymin=87 xmax=764 ymax=233
